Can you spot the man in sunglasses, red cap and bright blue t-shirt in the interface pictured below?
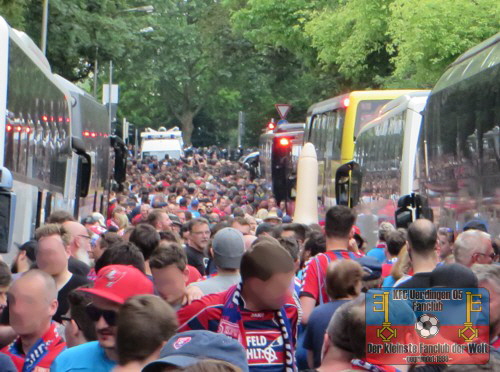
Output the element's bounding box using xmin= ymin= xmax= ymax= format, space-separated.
xmin=51 ymin=265 xmax=153 ymax=372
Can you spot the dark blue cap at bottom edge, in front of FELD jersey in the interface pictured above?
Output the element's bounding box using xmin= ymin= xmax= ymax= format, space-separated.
xmin=142 ymin=331 xmax=248 ymax=372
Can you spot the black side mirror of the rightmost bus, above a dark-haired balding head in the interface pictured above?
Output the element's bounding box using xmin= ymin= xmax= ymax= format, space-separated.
xmin=395 ymin=193 xmax=434 ymax=229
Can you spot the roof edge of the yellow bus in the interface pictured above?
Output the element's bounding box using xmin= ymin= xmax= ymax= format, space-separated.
xmin=307 ymin=89 xmax=422 ymax=116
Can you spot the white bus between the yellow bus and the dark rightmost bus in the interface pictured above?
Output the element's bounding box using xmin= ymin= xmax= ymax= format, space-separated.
xmin=344 ymin=91 xmax=430 ymax=246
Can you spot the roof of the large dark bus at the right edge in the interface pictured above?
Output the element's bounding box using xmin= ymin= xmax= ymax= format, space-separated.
xmin=431 ymin=32 xmax=500 ymax=94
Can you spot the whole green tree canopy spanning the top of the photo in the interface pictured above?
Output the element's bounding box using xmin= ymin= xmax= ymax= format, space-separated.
xmin=0 ymin=0 xmax=500 ymax=145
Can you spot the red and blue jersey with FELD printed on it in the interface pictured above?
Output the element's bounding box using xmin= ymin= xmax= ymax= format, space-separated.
xmin=177 ymin=288 xmax=299 ymax=372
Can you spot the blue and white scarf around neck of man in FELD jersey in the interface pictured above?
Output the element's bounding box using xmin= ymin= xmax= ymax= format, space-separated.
xmin=217 ymin=283 xmax=297 ymax=372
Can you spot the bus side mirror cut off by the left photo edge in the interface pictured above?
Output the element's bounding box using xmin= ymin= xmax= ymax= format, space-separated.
xmin=0 ymin=167 xmax=16 ymax=253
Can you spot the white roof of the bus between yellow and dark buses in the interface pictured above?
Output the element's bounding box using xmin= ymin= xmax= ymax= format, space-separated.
xmin=358 ymin=90 xmax=430 ymax=138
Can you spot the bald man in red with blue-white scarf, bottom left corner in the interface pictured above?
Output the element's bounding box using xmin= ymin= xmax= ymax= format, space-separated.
xmin=2 ymin=270 xmax=66 ymax=372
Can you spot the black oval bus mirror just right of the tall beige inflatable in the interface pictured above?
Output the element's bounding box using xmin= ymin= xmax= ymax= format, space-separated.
xmin=335 ymin=161 xmax=362 ymax=208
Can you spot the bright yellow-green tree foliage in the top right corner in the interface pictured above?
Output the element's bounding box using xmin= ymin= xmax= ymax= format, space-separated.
xmin=387 ymin=0 xmax=500 ymax=87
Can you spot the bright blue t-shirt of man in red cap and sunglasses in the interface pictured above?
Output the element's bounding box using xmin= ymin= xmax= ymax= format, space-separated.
xmin=50 ymin=341 xmax=116 ymax=372
